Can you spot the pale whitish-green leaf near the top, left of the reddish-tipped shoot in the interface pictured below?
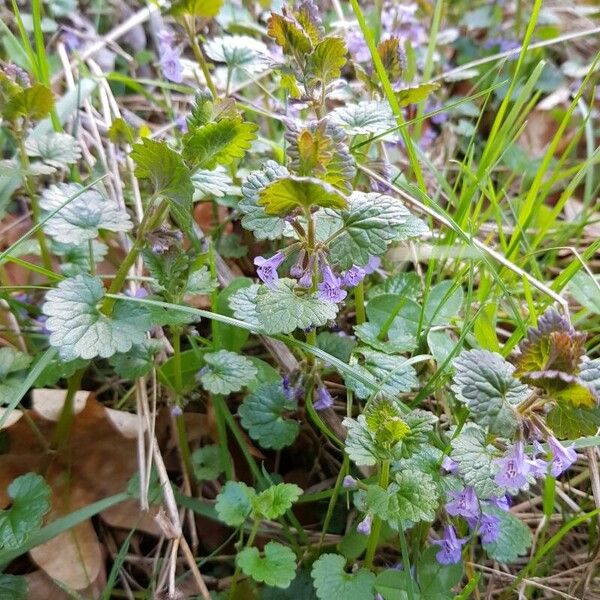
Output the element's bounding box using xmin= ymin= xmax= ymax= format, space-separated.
xmin=204 ymin=35 xmax=269 ymax=73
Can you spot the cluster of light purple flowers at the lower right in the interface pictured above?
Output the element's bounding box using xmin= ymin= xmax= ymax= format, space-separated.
xmin=434 ymin=436 xmax=577 ymax=564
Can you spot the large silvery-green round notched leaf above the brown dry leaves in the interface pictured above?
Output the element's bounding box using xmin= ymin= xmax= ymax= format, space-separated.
xmin=42 ymin=275 xmax=151 ymax=361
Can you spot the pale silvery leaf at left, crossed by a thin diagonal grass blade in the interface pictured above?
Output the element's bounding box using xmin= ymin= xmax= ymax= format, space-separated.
xmin=40 ymin=183 xmax=133 ymax=246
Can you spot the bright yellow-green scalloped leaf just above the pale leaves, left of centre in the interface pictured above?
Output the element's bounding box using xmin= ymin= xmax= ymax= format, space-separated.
xmin=183 ymin=117 xmax=258 ymax=169
